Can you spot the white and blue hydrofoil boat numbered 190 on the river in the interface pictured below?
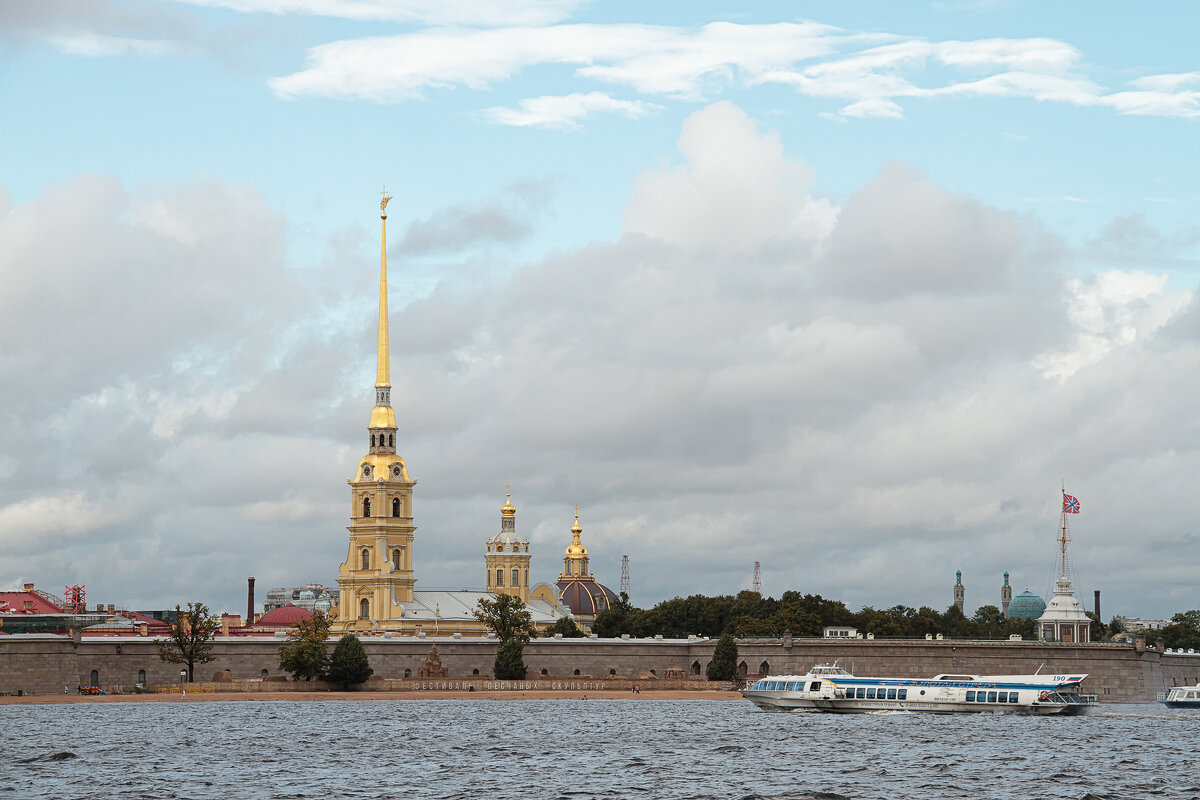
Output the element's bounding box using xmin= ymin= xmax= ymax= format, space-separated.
xmin=742 ymin=668 xmax=1096 ymax=715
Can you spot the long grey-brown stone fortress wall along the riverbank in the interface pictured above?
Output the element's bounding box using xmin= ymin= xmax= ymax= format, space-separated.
xmin=0 ymin=634 xmax=1200 ymax=702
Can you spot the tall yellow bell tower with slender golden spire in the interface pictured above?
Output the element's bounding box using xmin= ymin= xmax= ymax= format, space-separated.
xmin=336 ymin=190 xmax=416 ymax=631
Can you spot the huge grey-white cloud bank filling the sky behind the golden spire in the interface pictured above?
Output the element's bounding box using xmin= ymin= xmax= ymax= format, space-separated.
xmin=0 ymin=103 xmax=1200 ymax=615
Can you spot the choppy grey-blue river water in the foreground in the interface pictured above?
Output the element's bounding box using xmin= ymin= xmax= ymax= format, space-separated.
xmin=0 ymin=699 xmax=1200 ymax=800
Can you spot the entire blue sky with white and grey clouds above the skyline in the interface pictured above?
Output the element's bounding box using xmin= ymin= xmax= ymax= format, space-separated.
xmin=0 ymin=0 xmax=1200 ymax=619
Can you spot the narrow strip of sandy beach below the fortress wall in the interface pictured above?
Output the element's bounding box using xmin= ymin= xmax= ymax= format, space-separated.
xmin=0 ymin=690 xmax=742 ymax=705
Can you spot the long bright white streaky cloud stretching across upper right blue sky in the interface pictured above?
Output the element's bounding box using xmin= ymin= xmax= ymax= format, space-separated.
xmin=270 ymin=22 xmax=1200 ymax=127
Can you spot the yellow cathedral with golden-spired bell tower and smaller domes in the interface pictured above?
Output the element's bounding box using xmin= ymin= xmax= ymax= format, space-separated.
xmin=330 ymin=197 xmax=585 ymax=636
